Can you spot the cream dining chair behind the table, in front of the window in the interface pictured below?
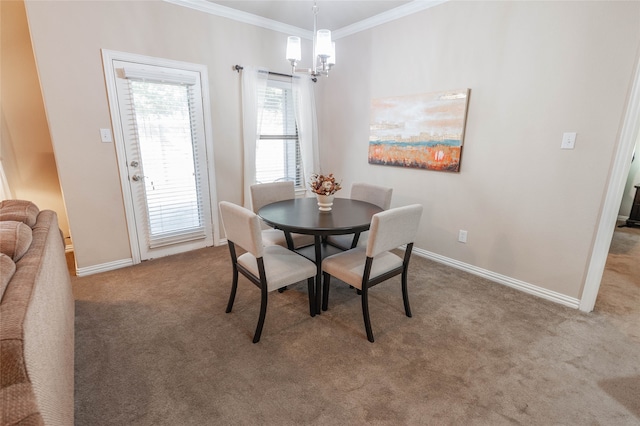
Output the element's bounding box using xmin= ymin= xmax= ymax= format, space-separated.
xmin=250 ymin=181 xmax=313 ymax=248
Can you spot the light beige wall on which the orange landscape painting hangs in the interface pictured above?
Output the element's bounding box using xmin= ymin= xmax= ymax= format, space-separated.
xmin=320 ymin=2 xmax=640 ymax=299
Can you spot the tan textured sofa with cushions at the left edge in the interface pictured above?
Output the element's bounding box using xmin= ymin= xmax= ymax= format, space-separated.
xmin=0 ymin=200 xmax=75 ymax=425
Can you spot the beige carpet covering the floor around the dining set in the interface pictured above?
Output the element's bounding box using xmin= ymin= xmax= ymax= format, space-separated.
xmin=72 ymin=233 xmax=640 ymax=425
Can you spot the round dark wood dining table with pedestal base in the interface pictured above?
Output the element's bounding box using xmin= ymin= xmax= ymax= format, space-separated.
xmin=258 ymin=198 xmax=382 ymax=314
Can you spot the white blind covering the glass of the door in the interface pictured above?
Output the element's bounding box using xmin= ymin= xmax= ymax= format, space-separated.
xmin=125 ymin=75 xmax=205 ymax=248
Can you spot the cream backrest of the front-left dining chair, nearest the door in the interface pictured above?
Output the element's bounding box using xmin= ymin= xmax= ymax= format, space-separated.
xmin=220 ymin=201 xmax=264 ymax=257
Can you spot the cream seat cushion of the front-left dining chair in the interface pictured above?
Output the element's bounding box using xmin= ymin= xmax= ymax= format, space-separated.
xmin=238 ymin=246 xmax=316 ymax=291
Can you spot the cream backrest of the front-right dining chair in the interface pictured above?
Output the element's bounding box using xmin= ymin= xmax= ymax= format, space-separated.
xmin=367 ymin=204 xmax=422 ymax=257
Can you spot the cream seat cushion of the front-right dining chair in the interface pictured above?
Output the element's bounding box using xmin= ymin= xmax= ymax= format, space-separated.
xmin=322 ymin=247 xmax=402 ymax=289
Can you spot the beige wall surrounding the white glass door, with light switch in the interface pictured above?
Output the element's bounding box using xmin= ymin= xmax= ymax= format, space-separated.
xmin=26 ymin=1 xmax=296 ymax=268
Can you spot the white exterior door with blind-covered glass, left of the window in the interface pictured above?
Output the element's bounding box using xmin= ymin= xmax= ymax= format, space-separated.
xmin=105 ymin=55 xmax=215 ymax=263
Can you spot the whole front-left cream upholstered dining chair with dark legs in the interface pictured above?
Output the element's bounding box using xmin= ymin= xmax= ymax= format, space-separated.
xmin=220 ymin=201 xmax=316 ymax=343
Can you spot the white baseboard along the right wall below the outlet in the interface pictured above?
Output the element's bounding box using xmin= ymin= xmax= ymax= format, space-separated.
xmin=412 ymin=248 xmax=580 ymax=309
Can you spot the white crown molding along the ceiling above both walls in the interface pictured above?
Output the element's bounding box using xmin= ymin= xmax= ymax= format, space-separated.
xmin=164 ymin=0 xmax=449 ymax=40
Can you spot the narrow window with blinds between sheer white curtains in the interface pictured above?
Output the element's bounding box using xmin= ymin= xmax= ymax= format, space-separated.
xmin=256 ymin=75 xmax=304 ymax=188
